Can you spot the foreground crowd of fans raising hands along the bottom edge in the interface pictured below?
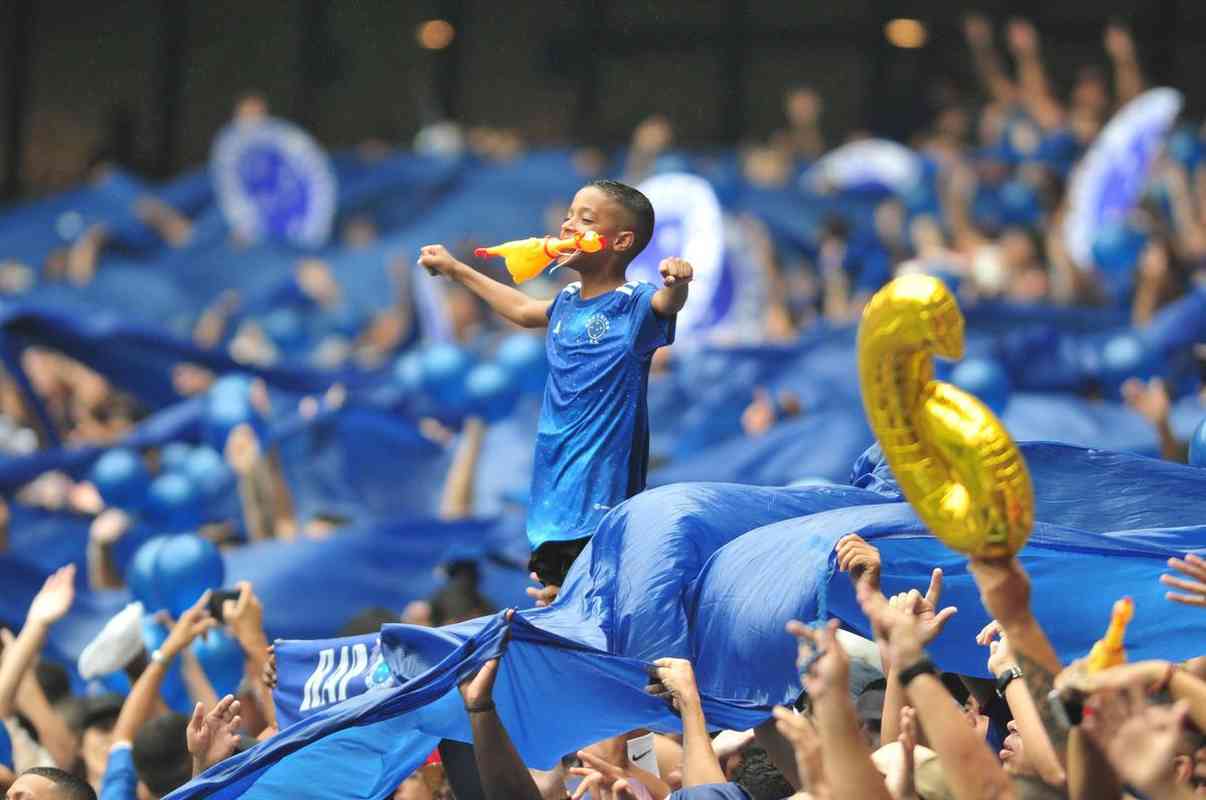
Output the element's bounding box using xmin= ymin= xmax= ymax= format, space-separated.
xmin=0 ymin=533 xmax=1206 ymax=800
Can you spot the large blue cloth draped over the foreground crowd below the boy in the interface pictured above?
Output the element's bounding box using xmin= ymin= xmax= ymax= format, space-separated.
xmin=171 ymin=443 xmax=1206 ymax=798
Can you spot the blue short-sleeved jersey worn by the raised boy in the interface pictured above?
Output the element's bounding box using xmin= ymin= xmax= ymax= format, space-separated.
xmin=527 ymin=281 xmax=674 ymax=550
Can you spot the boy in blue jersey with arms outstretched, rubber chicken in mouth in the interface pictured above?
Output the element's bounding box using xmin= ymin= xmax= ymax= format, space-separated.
xmin=418 ymin=181 xmax=692 ymax=605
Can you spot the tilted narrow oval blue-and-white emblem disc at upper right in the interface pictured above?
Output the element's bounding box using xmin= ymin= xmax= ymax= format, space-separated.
xmin=1064 ymin=88 xmax=1182 ymax=269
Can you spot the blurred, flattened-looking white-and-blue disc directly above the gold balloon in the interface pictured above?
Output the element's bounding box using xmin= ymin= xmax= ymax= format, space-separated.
xmin=800 ymin=139 xmax=921 ymax=194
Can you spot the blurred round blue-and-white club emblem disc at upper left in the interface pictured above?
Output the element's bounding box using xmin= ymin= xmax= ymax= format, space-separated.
xmin=210 ymin=119 xmax=336 ymax=247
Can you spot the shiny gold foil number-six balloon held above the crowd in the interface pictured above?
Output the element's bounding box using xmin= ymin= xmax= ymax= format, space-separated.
xmin=859 ymin=275 xmax=1035 ymax=557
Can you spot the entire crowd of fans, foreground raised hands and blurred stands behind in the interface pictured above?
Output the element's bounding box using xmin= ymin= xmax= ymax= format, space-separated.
xmin=0 ymin=10 xmax=1206 ymax=800
